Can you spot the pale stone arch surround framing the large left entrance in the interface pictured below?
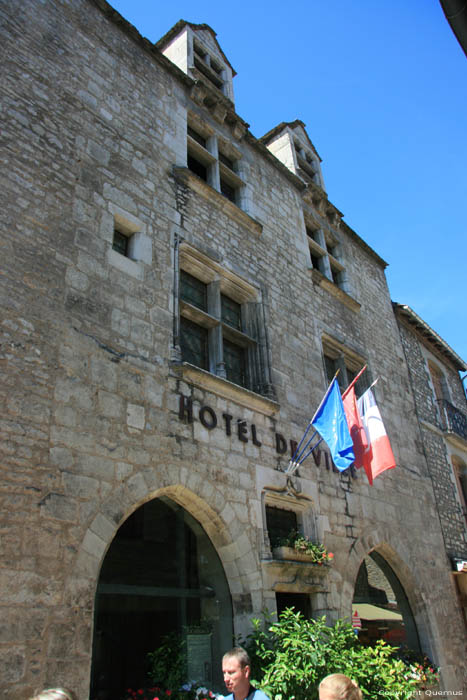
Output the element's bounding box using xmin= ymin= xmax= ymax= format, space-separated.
xmin=64 ymin=465 xmax=256 ymax=697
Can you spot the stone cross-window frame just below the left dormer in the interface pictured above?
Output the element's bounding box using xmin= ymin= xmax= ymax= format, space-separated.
xmin=187 ymin=113 xmax=246 ymax=209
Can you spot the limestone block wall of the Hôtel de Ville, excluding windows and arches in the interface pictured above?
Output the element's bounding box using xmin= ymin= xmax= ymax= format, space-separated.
xmin=0 ymin=0 xmax=464 ymax=700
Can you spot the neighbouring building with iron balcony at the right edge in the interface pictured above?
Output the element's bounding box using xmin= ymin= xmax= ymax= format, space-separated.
xmin=394 ymin=304 xmax=467 ymax=622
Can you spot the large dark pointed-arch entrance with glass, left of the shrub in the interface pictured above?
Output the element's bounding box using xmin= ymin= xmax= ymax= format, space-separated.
xmin=91 ymin=497 xmax=233 ymax=700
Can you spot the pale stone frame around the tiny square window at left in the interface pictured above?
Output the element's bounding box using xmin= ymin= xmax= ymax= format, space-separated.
xmin=103 ymin=204 xmax=152 ymax=279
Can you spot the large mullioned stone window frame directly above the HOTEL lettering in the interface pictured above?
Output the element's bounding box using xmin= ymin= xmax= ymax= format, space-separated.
xmin=174 ymin=241 xmax=277 ymax=402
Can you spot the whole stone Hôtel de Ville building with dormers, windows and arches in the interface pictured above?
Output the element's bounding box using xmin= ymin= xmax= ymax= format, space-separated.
xmin=0 ymin=0 xmax=466 ymax=700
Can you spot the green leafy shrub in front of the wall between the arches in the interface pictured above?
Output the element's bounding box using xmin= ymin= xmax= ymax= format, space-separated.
xmin=243 ymin=609 xmax=428 ymax=700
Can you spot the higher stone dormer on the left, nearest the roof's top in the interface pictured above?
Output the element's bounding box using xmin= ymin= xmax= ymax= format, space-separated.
xmin=156 ymin=20 xmax=236 ymax=104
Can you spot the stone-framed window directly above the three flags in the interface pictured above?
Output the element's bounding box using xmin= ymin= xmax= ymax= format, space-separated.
xmin=321 ymin=333 xmax=371 ymax=396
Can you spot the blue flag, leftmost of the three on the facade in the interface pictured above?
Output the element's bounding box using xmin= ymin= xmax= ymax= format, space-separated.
xmin=311 ymin=378 xmax=355 ymax=472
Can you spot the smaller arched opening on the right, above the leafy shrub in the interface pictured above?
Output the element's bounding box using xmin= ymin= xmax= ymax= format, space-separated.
xmin=352 ymin=551 xmax=420 ymax=654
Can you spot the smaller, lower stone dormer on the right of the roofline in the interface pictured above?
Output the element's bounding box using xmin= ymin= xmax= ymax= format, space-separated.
xmin=261 ymin=119 xmax=324 ymax=191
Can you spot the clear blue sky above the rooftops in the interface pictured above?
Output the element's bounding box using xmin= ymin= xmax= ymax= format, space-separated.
xmin=111 ymin=0 xmax=467 ymax=370
